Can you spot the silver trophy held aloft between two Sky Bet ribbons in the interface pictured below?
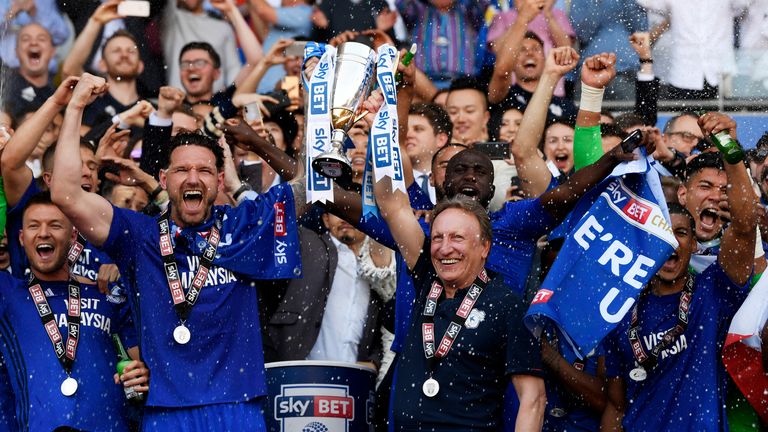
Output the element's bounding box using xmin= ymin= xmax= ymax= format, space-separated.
xmin=312 ymin=42 xmax=374 ymax=180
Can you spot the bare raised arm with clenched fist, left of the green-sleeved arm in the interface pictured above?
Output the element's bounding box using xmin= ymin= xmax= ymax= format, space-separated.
xmin=512 ymin=47 xmax=579 ymax=197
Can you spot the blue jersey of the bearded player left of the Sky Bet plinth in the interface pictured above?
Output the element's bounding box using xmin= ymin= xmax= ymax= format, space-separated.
xmin=103 ymin=184 xmax=301 ymax=407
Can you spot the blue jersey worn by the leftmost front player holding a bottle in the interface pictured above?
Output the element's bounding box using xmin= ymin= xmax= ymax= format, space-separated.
xmin=0 ymin=273 xmax=136 ymax=431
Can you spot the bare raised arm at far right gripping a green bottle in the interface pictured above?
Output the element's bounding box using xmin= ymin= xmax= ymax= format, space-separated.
xmin=699 ymin=112 xmax=757 ymax=285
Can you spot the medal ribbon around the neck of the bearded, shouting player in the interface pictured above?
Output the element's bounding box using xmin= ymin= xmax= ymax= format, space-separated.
xmin=157 ymin=207 xmax=221 ymax=322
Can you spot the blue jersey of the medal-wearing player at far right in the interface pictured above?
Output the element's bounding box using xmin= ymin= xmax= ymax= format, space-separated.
xmin=605 ymin=262 xmax=749 ymax=431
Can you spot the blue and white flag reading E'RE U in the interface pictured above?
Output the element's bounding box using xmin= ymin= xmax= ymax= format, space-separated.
xmin=524 ymin=157 xmax=677 ymax=358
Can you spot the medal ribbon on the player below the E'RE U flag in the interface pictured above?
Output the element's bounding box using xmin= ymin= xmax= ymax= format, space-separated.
xmin=628 ymin=275 xmax=693 ymax=370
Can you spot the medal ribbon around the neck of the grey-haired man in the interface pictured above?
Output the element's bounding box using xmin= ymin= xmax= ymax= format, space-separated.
xmin=421 ymin=269 xmax=490 ymax=371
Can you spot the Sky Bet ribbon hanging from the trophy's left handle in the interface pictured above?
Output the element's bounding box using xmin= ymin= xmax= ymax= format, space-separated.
xmin=304 ymin=45 xmax=336 ymax=203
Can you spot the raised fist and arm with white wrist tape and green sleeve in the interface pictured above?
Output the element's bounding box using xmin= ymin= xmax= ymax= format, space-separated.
xmin=573 ymin=53 xmax=616 ymax=170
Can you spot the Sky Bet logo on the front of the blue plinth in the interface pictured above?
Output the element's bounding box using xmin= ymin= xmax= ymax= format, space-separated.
xmin=274 ymin=384 xmax=355 ymax=432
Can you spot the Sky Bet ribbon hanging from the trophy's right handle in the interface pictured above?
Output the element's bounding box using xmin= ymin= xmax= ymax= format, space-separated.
xmin=363 ymin=45 xmax=407 ymax=219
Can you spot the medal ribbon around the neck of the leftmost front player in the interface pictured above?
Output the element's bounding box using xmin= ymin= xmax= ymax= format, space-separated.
xmin=28 ymin=276 xmax=80 ymax=375
